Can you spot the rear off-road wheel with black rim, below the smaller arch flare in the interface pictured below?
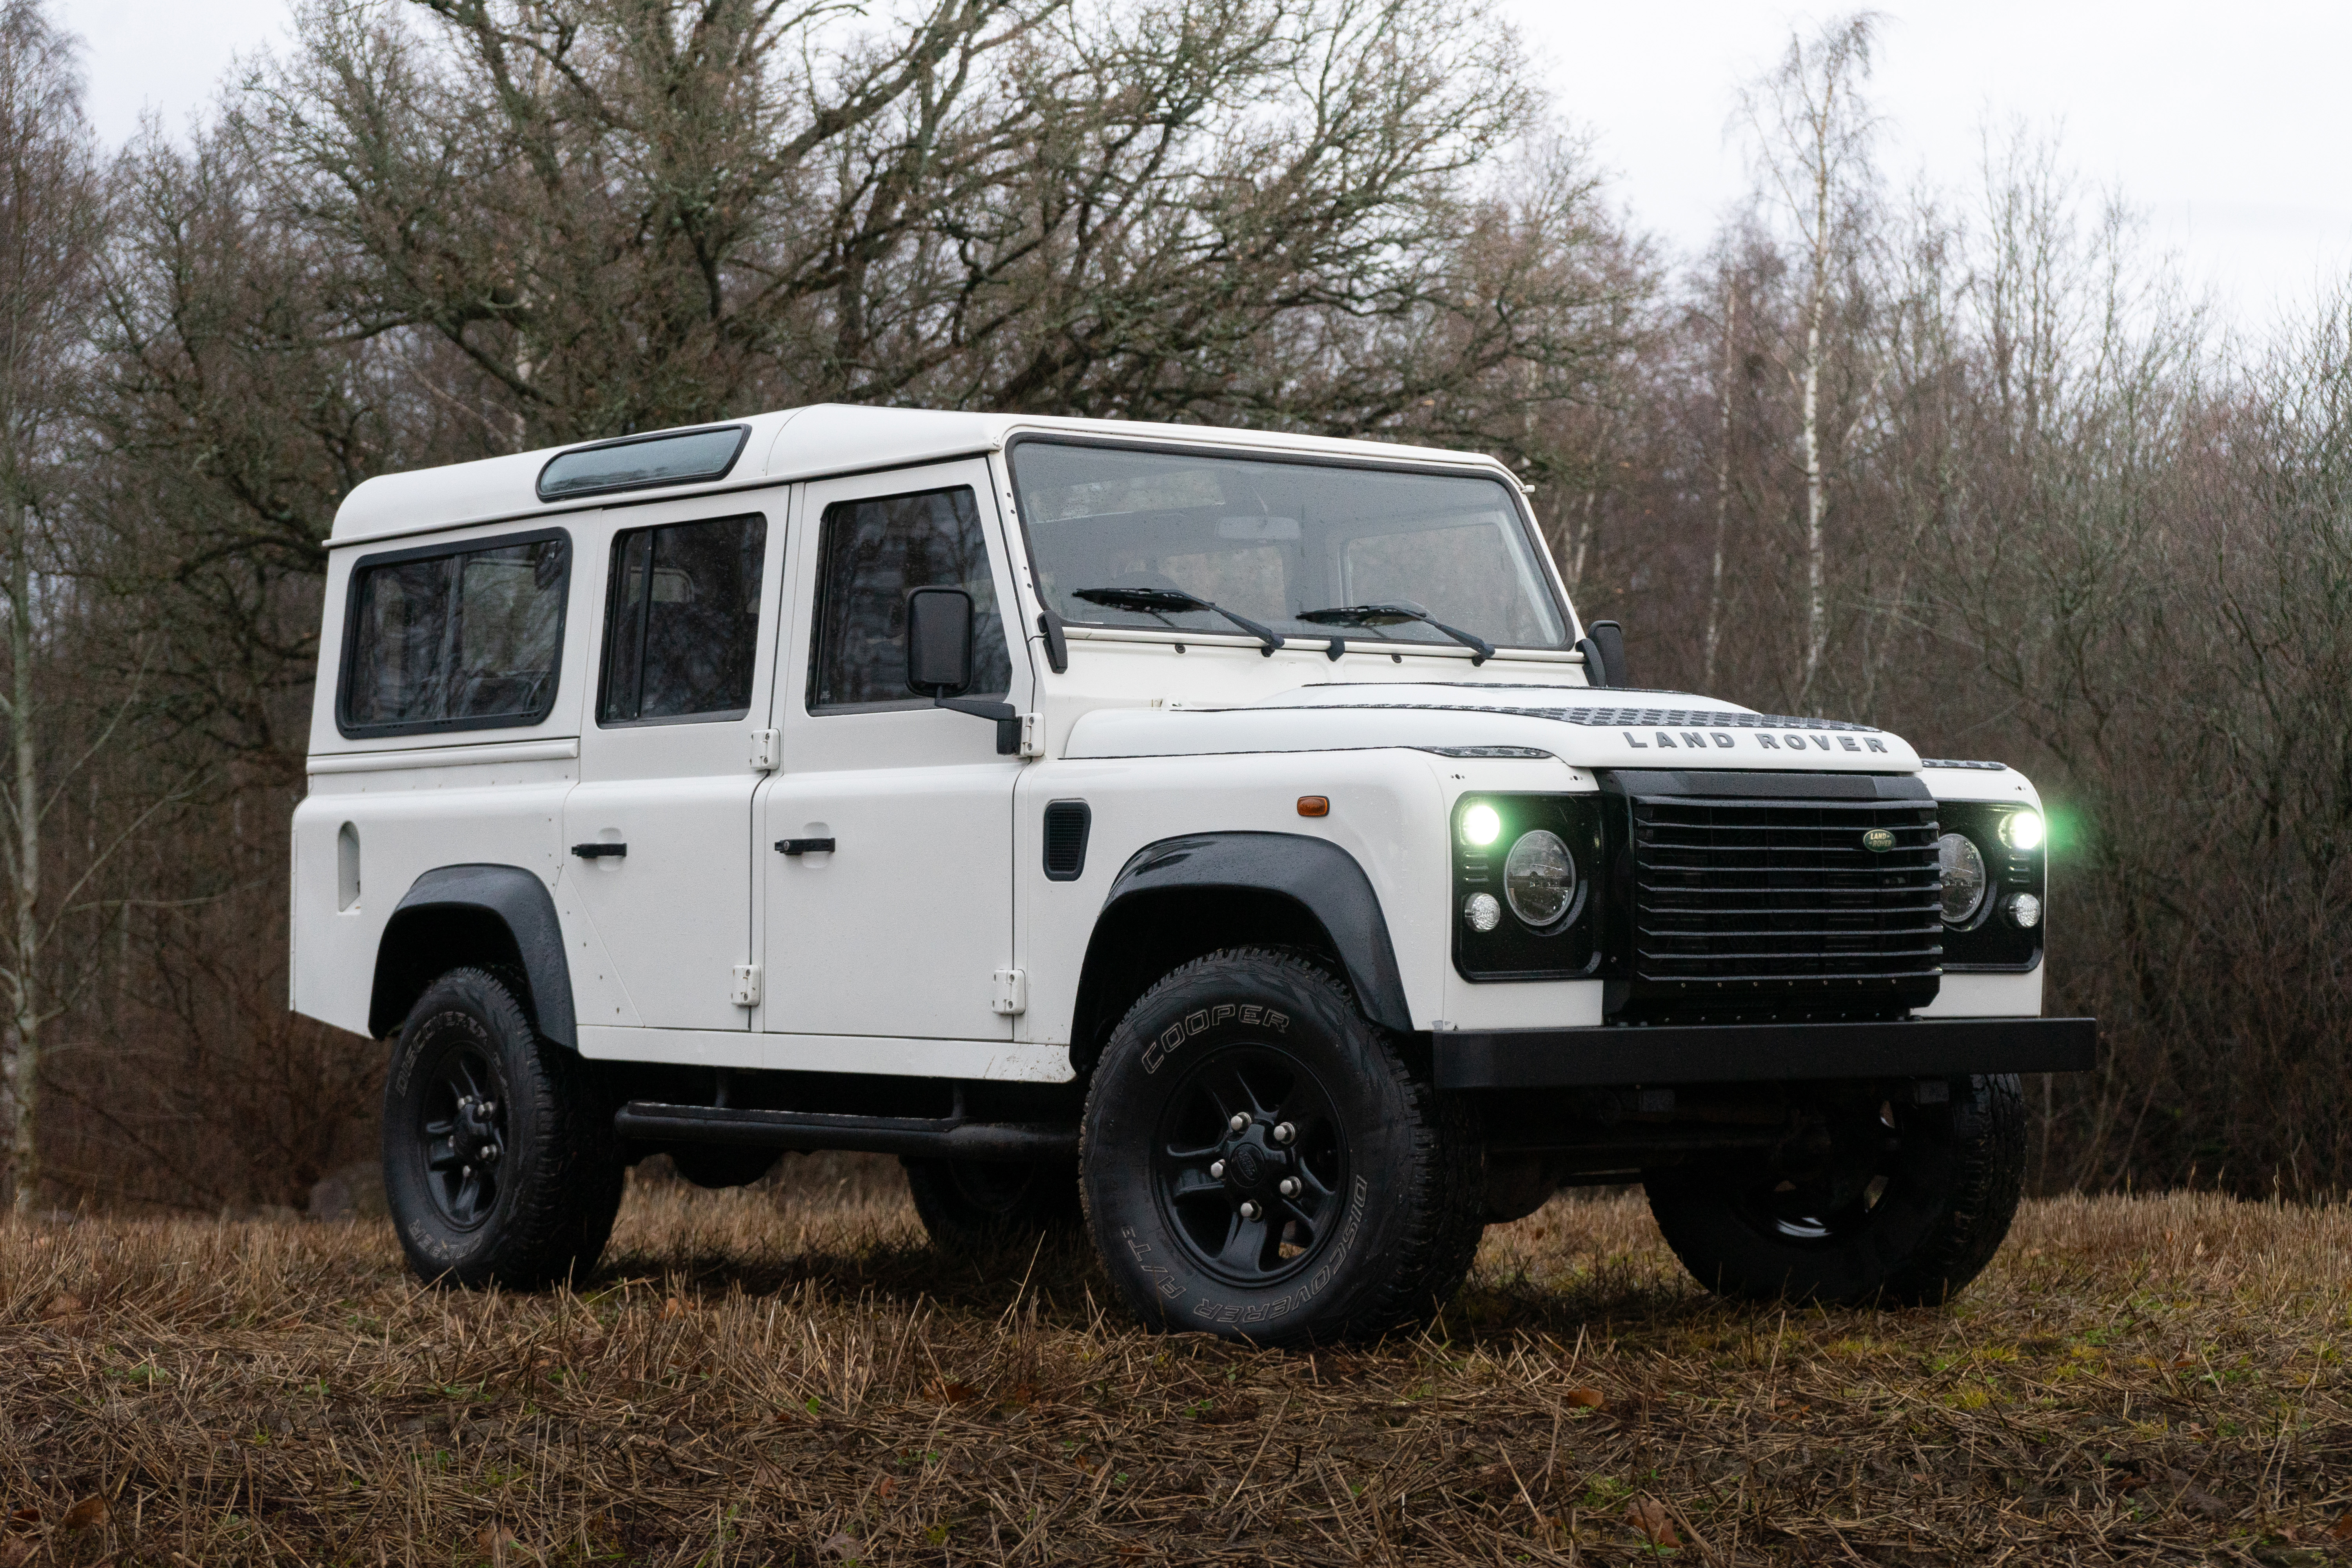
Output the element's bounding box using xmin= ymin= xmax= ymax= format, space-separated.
xmin=383 ymin=969 xmax=623 ymax=1288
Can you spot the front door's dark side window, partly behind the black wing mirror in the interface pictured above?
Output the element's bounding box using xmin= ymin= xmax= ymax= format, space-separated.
xmin=809 ymin=486 xmax=1014 ymax=712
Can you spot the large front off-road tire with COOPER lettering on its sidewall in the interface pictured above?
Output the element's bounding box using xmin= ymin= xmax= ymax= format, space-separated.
xmin=1080 ymin=947 xmax=1484 ymax=1345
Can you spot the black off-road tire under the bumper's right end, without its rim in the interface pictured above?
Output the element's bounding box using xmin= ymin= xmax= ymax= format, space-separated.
xmin=1644 ymin=1074 xmax=2025 ymax=1307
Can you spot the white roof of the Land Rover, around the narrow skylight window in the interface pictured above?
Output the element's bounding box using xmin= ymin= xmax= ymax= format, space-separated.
xmin=329 ymin=402 xmax=1505 ymax=545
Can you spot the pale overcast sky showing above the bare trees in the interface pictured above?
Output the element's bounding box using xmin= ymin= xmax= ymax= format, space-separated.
xmin=64 ymin=0 xmax=2352 ymax=327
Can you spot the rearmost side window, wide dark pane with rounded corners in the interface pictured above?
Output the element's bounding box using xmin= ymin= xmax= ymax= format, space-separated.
xmin=336 ymin=534 xmax=572 ymax=736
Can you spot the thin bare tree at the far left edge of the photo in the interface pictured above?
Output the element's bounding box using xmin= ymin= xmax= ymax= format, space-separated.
xmin=0 ymin=0 xmax=101 ymax=1213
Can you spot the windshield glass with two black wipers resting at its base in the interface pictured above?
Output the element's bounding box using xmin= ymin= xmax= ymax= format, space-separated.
xmin=1011 ymin=439 xmax=1569 ymax=649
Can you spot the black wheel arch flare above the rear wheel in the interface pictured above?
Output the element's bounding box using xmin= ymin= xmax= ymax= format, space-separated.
xmin=367 ymin=865 xmax=579 ymax=1051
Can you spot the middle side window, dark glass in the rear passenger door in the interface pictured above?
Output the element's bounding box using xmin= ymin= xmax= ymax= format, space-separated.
xmin=595 ymin=512 xmax=767 ymax=724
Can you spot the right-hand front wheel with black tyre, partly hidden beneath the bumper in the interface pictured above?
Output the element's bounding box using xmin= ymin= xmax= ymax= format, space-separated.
xmin=1644 ymin=1074 xmax=2025 ymax=1307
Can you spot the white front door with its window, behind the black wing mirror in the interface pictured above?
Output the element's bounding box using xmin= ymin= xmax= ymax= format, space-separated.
xmin=755 ymin=461 xmax=1030 ymax=1039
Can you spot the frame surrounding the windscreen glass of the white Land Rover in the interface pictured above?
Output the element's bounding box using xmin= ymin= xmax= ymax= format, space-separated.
xmin=1004 ymin=430 xmax=1585 ymax=656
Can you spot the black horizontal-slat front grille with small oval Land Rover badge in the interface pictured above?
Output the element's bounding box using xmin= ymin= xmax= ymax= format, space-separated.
xmin=1628 ymin=795 xmax=1943 ymax=1018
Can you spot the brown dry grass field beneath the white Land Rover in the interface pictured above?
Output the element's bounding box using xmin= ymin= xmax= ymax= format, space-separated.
xmin=0 ymin=1157 xmax=2352 ymax=1568
